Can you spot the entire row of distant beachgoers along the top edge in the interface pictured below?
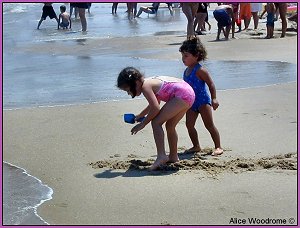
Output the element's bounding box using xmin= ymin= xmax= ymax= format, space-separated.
xmin=37 ymin=2 xmax=298 ymax=40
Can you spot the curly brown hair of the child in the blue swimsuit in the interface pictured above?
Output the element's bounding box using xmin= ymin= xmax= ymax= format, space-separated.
xmin=179 ymin=38 xmax=207 ymax=61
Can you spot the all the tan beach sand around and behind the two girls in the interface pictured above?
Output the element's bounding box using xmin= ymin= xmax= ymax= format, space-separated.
xmin=3 ymin=4 xmax=298 ymax=225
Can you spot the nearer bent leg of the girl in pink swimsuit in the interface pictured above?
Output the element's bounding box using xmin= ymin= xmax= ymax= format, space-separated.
xmin=150 ymin=98 xmax=188 ymax=170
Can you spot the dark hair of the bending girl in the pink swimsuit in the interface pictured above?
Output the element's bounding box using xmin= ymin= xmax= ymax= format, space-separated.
xmin=117 ymin=67 xmax=144 ymax=98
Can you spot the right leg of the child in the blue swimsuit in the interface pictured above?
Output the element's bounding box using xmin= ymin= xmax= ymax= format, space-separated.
xmin=200 ymin=105 xmax=223 ymax=155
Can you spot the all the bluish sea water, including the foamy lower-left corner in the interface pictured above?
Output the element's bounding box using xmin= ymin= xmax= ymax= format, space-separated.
xmin=3 ymin=3 xmax=297 ymax=225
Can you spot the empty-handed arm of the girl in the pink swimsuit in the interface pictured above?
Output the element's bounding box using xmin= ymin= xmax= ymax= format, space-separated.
xmin=131 ymin=83 xmax=160 ymax=134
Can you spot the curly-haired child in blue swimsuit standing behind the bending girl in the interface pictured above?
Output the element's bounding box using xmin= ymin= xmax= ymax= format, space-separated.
xmin=179 ymin=38 xmax=223 ymax=155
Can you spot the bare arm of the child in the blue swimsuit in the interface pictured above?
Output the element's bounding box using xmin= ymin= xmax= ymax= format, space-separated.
xmin=196 ymin=67 xmax=219 ymax=110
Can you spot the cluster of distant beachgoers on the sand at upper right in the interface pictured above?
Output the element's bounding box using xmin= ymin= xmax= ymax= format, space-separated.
xmin=181 ymin=2 xmax=298 ymax=40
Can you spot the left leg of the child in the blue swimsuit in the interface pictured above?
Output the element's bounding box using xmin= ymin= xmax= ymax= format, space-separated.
xmin=186 ymin=109 xmax=201 ymax=152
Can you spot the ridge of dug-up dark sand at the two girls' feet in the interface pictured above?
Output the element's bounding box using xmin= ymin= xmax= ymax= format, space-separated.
xmin=89 ymin=150 xmax=297 ymax=174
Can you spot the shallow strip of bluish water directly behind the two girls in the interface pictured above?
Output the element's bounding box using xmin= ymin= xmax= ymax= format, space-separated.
xmin=3 ymin=55 xmax=297 ymax=109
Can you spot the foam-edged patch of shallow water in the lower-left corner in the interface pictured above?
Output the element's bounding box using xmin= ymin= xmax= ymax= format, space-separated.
xmin=2 ymin=162 xmax=53 ymax=225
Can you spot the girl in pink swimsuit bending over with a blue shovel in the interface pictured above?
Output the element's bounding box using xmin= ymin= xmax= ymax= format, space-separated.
xmin=117 ymin=67 xmax=195 ymax=170
